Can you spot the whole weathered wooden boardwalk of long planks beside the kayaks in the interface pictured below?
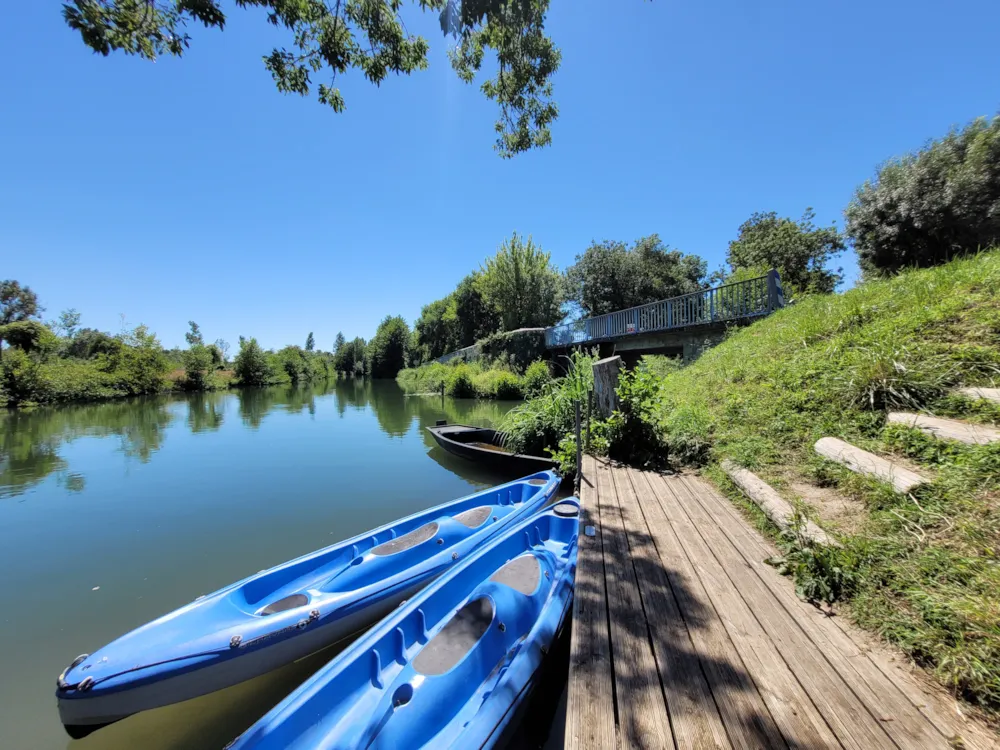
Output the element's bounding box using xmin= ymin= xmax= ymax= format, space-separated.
xmin=565 ymin=457 xmax=998 ymax=750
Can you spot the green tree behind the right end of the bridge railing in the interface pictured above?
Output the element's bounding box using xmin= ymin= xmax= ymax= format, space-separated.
xmin=726 ymin=208 xmax=844 ymax=294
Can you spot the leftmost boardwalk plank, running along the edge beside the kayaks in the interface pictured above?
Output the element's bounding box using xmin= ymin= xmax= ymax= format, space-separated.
xmin=564 ymin=456 xmax=615 ymax=750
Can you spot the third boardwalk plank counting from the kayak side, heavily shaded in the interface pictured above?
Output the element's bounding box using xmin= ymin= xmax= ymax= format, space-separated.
xmin=615 ymin=469 xmax=732 ymax=750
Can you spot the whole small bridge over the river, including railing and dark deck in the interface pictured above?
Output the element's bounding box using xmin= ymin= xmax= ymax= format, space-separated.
xmin=545 ymin=269 xmax=785 ymax=359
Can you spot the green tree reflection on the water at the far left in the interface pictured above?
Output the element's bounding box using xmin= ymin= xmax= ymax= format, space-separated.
xmin=0 ymin=397 xmax=174 ymax=498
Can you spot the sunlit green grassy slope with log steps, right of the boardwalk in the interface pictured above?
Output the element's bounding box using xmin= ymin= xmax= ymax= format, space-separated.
xmin=660 ymin=251 xmax=1000 ymax=718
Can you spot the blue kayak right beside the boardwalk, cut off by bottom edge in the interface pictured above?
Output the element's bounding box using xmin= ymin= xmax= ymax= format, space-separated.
xmin=228 ymin=499 xmax=580 ymax=750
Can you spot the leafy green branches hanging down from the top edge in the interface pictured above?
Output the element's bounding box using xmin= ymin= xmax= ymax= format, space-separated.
xmin=63 ymin=0 xmax=561 ymax=157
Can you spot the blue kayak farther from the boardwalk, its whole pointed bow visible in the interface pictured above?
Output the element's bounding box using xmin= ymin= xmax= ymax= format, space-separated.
xmin=56 ymin=471 xmax=560 ymax=737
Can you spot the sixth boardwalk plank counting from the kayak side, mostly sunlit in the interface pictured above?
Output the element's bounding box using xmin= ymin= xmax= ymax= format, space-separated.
xmin=673 ymin=480 xmax=891 ymax=750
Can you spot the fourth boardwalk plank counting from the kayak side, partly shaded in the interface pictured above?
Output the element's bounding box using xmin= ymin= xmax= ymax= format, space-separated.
xmin=624 ymin=475 xmax=786 ymax=750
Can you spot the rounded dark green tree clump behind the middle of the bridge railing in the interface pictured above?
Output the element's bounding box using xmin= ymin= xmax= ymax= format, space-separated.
xmin=566 ymin=234 xmax=706 ymax=315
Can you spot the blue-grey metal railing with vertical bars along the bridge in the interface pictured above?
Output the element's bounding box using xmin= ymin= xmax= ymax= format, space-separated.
xmin=545 ymin=270 xmax=785 ymax=349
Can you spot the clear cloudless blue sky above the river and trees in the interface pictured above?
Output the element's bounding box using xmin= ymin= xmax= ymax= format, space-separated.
xmin=0 ymin=0 xmax=1000 ymax=349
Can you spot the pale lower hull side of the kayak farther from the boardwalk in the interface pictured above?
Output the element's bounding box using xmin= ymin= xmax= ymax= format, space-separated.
xmin=58 ymin=581 xmax=418 ymax=739
